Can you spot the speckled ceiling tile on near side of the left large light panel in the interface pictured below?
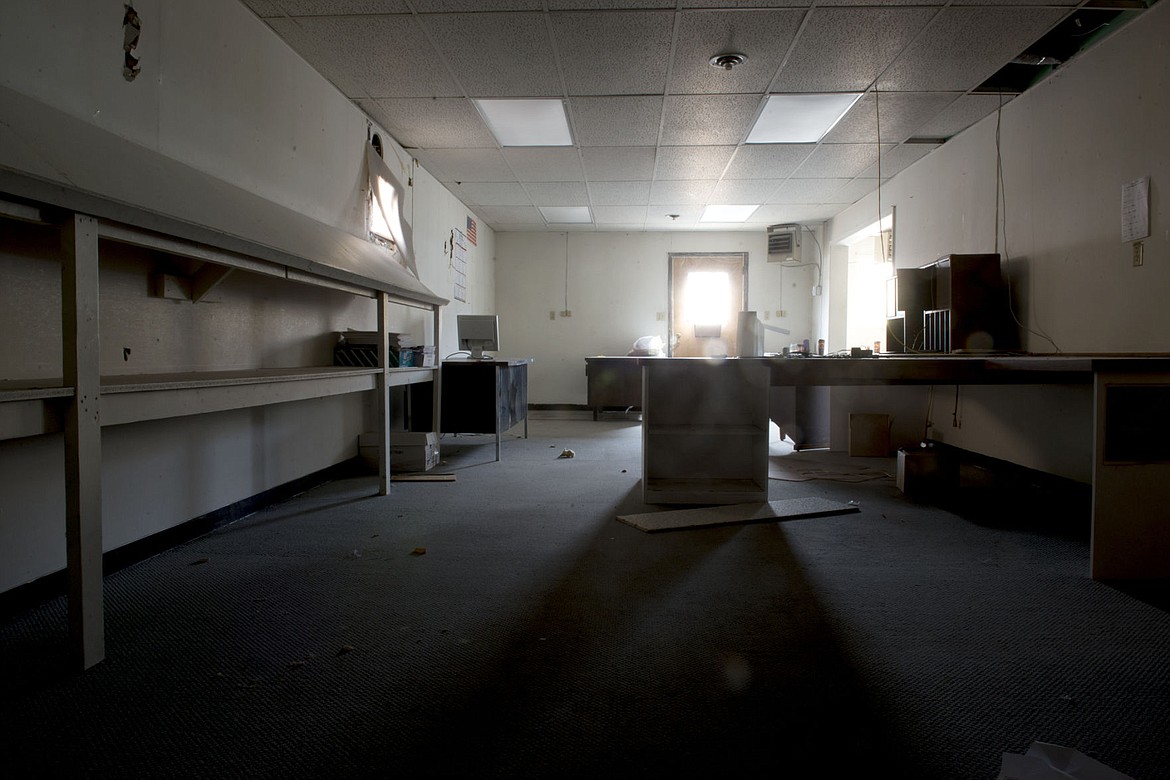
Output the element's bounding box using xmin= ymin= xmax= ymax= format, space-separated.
xmin=423 ymin=13 xmax=564 ymax=97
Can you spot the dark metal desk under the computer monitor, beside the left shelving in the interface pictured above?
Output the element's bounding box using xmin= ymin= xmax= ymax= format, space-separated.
xmin=411 ymin=358 xmax=532 ymax=461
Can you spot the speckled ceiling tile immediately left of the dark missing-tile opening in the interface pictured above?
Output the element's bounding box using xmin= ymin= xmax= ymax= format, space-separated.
xmin=879 ymin=7 xmax=1067 ymax=92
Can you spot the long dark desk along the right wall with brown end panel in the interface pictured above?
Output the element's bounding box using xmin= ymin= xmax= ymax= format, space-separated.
xmin=641 ymin=354 xmax=1170 ymax=580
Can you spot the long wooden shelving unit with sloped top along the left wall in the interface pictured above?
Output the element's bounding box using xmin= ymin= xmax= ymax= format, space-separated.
xmin=0 ymin=143 xmax=447 ymax=669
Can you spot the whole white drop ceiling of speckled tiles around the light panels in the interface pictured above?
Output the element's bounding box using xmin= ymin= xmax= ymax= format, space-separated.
xmin=243 ymin=0 xmax=1152 ymax=230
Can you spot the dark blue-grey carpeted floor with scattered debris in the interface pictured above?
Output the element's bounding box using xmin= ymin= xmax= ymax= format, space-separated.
xmin=0 ymin=419 xmax=1170 ymax=780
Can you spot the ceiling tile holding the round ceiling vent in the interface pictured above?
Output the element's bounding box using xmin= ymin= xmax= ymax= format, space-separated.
xmin=669 ymin=9 xmax=805 ymax=95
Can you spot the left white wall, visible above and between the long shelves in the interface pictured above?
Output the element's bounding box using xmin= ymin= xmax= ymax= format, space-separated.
xmin=0 ymin=0 xmax=495 ymax=591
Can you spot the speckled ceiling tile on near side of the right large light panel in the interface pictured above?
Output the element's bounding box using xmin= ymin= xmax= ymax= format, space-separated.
xmin=769 ymin=7 xmax=937 ymax=92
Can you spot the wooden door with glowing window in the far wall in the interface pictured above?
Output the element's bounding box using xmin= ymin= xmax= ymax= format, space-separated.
xmin=667 ymin=251 xmax=748 ymax=358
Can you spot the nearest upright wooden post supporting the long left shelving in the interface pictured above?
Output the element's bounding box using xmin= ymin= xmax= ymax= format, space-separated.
xmin=61 ymin=214 xmax=105 ymax=670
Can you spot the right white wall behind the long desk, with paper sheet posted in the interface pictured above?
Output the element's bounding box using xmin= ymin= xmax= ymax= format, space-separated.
xmin=828 ymin=4 xmax=1170 ymax=481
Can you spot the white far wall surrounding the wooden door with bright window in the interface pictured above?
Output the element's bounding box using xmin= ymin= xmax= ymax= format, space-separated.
xmin=496 ymin=230 xmax=820 ymax=405
